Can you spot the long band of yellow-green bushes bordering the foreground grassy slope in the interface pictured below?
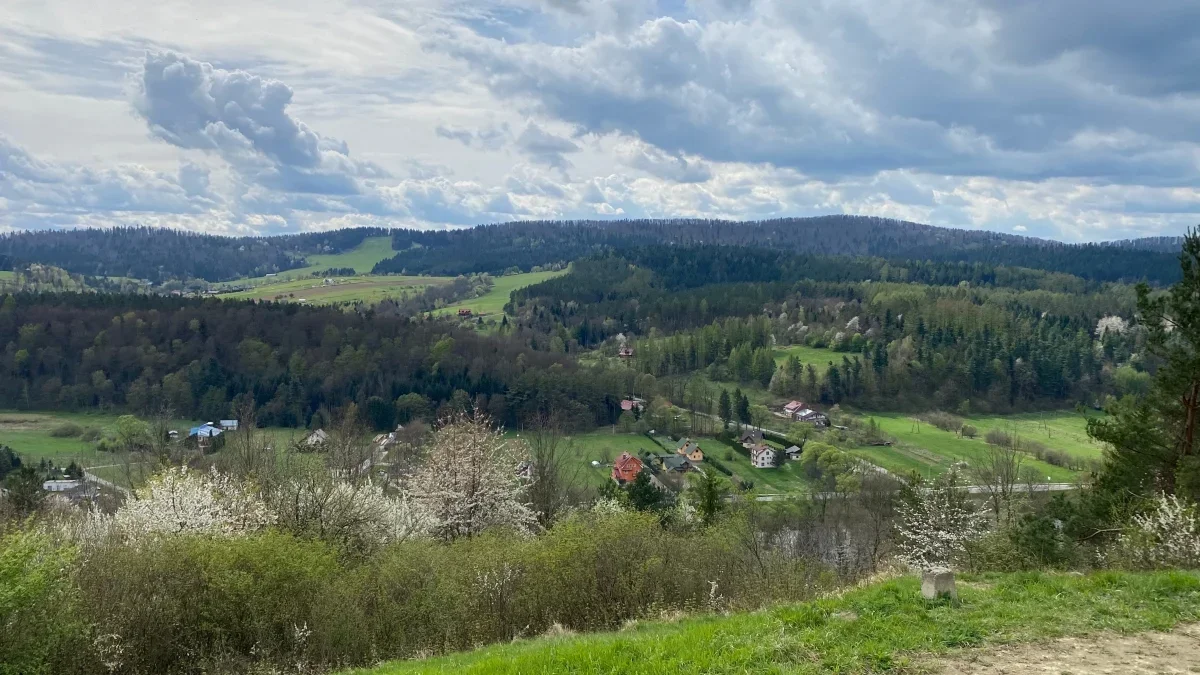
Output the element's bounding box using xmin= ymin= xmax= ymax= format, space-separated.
xmin=44 ymin=510 xmax=835 ymax=674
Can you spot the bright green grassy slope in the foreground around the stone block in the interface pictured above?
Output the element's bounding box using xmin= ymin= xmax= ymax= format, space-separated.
xmin=355 ymin=572 xmax=1200 ymax=675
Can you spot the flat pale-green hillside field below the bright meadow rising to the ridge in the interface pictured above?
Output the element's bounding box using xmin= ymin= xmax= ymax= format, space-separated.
xmin=221 ymin=275 xmax=451 ymax=305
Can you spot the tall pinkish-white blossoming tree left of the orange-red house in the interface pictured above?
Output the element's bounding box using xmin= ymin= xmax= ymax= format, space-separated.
xmin=409 ymin=412 xmax=536 ymax=539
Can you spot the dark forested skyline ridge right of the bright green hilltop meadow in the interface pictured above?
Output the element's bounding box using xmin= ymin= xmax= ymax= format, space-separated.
xmin=376 ymin=215 xmax=1178 ymax=283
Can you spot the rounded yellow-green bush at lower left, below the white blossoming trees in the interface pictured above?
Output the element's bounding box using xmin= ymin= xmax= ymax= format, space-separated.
xmin=79 ymin=533 xmax=338 ymax=673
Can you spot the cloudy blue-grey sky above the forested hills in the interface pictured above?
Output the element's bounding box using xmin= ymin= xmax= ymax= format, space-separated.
xmin=0 ymin=0 xmax=1200 ymax=241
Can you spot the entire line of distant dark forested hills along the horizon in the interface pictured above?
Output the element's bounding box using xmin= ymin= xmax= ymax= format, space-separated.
xmin=0 ymin=215 xmax=1182 ymax=283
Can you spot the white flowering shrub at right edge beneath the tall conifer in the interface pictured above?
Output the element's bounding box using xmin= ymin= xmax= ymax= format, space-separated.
xmin=1116 ymin=487 xmax=1200 ymax=568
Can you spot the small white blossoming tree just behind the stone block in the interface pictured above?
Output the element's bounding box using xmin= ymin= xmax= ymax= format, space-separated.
xmin=896 ymin=471 xmax=988 ymax=571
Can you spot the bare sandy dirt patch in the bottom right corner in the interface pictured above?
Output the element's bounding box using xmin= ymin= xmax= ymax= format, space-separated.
xmin=932 ymin=623 xmax=1200 ymax=675
